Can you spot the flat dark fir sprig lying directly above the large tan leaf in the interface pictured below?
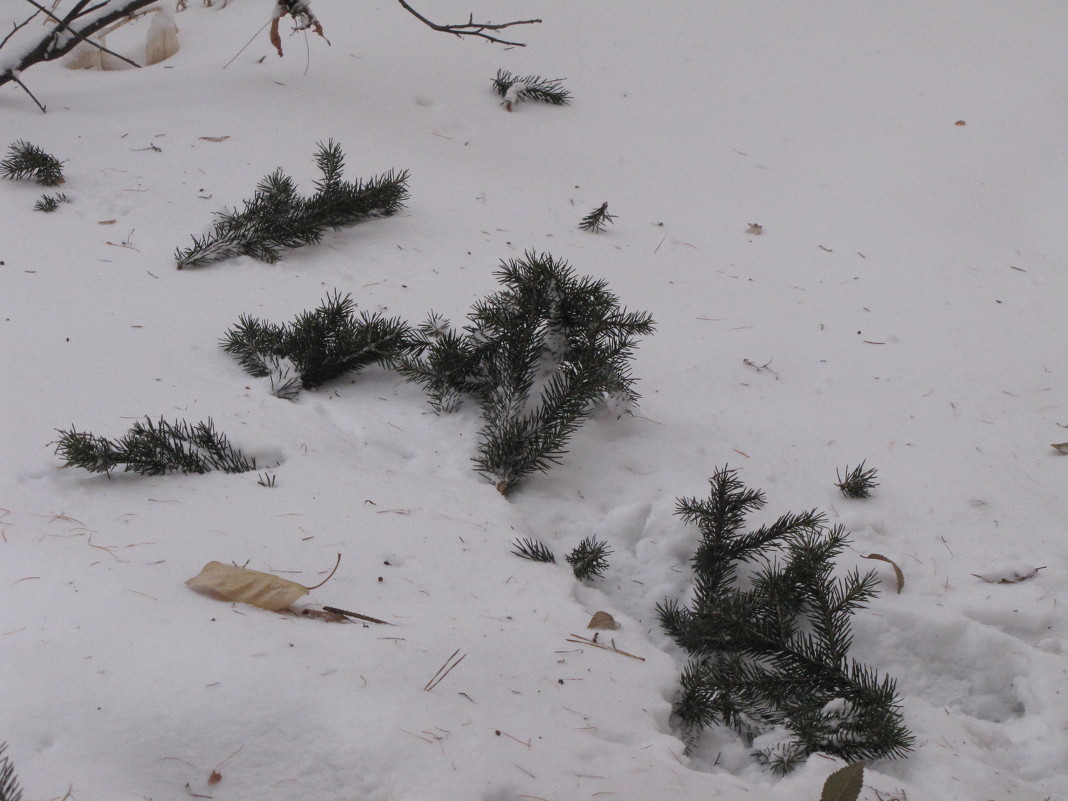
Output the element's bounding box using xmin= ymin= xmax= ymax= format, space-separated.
xmin=54 ymin=418 xmax=256 ymax=475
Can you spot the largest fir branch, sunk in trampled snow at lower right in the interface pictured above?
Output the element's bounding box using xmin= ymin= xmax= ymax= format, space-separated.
xmin=658 ymin=468 xmax=913 ymax=772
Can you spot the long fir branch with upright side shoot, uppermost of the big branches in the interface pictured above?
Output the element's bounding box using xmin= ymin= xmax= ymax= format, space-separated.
xmin=175 ymin=140 xmax=408 ymax=270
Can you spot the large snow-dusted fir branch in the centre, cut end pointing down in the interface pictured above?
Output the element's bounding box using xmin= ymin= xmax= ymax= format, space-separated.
xmin=395 ymin=252 xmax=654 ymax=493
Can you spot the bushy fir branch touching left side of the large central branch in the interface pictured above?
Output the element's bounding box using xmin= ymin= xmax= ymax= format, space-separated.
xmin=221 ymin=292 xmax=410 ymax=399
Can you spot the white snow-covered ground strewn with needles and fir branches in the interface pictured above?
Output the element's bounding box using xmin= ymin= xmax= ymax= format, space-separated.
xmin=0 ymin=0 xmax=1068 ymax=801
